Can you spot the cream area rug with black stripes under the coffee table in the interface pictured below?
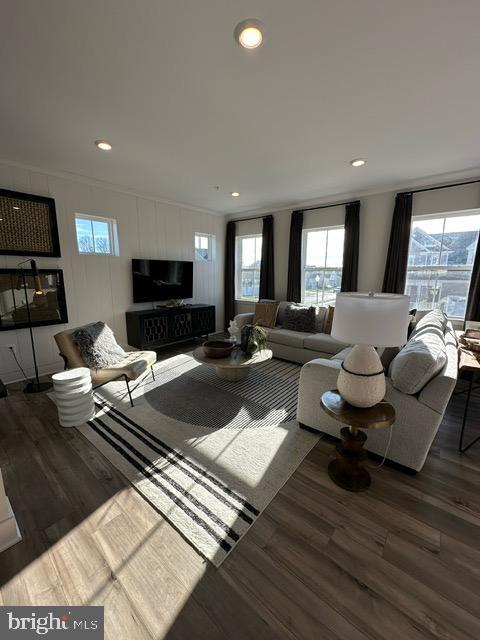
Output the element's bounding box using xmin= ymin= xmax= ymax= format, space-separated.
xmin=79 ymin=355 xmax=318 ymax=566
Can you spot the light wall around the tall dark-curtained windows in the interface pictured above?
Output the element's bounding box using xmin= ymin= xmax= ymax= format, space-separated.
xmin=228 ymin=184 xmax=480 ymax=313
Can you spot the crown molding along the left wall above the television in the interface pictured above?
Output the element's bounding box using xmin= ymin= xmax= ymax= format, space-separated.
xmin=0 ymin=158 xmax=225 ymax=217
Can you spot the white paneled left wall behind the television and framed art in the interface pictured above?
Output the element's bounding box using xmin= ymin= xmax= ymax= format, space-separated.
xmin=0 ymin=163 xmax=225 ymax=382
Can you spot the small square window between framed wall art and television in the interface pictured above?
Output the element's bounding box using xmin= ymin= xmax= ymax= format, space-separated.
xmin=75 ymin=214 xmax=119 ymax=256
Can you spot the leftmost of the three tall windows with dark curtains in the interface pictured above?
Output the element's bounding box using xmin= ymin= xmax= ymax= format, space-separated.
xmin=235 ymin=235 xmax=262 ymax=302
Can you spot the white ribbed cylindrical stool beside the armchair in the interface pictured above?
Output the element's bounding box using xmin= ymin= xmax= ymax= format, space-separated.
xmin=52 ymin=367 xmax=95 ymax=427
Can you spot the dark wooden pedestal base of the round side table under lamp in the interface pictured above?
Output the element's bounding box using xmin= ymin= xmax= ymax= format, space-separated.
xmin=328 ymin=427 xmax=371 ymax=491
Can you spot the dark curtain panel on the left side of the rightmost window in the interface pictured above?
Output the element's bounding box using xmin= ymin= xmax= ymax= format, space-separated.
xmin=382 ymin=193 xmax=412 ymax=293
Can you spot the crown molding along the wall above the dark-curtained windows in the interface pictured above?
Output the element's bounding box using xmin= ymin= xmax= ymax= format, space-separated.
xmin=226 ymin=167 xmax=480 ymax=220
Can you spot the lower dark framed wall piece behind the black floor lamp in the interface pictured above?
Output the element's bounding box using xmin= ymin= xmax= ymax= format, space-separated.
xmin=0 ymin=269 xmax=68 ymax=331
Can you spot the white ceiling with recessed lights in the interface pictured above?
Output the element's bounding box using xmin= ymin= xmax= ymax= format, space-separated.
xmin=0 ymin=0 xmax=480 ymax=213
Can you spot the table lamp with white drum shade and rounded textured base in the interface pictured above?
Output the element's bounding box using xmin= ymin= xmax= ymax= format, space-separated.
xmin=332 ymin=293 xmax=410 ymax=408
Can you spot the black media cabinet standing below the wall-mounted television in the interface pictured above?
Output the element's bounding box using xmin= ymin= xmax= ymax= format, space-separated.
xmin=125 ymin=304 xmax=215 ymax=350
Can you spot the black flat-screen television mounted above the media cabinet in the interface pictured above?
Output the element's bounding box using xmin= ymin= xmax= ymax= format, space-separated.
xmin=132 ymin=258 xmax=193 ymax=302
